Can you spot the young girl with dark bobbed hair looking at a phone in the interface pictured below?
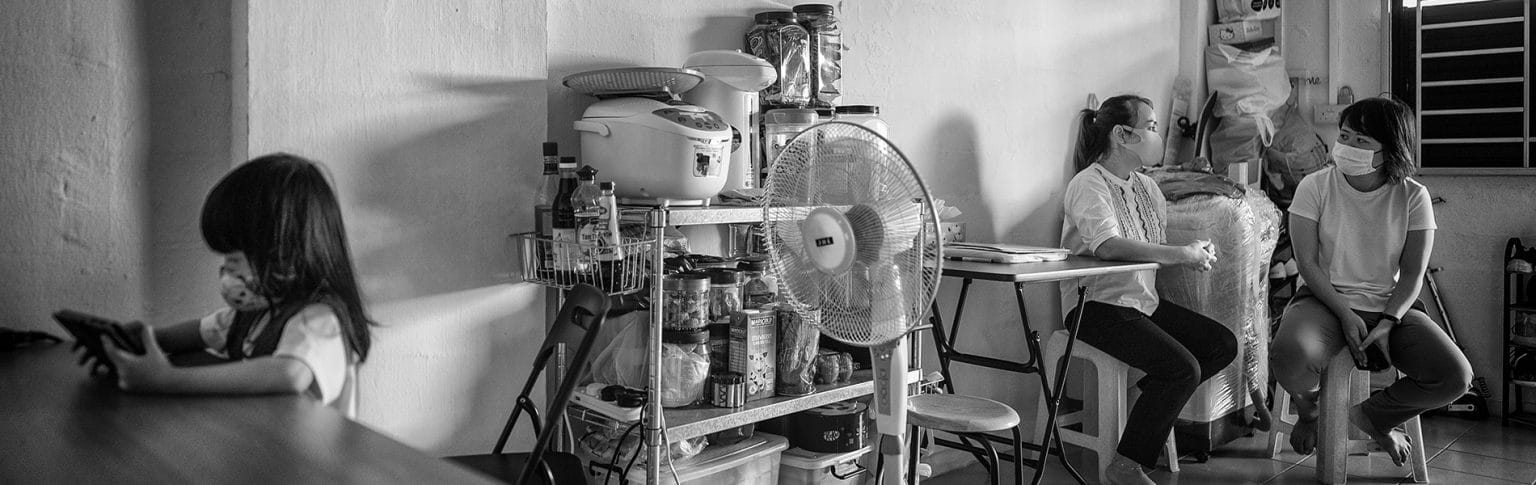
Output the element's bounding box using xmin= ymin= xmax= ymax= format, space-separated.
xmin=106 ymin=153 xmax=372 ymax=413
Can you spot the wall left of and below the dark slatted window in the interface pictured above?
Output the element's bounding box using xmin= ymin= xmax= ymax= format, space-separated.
xmin=1286 ymin=2 xmax=1536 ymax=413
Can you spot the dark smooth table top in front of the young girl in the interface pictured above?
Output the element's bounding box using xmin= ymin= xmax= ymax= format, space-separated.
xmin=0 ymin=342 xmax=493 ymax=483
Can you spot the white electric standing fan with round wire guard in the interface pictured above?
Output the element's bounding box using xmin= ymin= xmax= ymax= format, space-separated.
xmin=762 ymin=121 xmax=942 ymax=485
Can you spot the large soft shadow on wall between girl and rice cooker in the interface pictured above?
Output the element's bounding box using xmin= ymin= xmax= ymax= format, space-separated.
xmin=347 ymin=77 xmax=544 ymax=301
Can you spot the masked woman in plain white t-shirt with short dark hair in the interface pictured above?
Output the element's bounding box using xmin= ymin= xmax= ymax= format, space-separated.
xmin=1269 ymin=98 xmax=1471 ymax=465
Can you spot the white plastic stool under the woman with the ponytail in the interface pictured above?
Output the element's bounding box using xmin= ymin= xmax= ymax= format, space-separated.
xmin=1035 ymin=330 xmax=1178 ymax=482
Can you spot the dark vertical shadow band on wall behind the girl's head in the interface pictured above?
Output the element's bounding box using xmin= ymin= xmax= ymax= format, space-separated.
xmin=135 ymin=0 xmax=238 ymax=322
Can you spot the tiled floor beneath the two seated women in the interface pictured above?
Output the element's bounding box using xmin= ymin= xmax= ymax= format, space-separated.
xmin=923 ymin=416 xmax=1536 ymax=485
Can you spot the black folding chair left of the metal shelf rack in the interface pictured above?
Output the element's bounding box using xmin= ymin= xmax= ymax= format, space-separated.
xmin=447 ymin=284 xmax=608 ymax=485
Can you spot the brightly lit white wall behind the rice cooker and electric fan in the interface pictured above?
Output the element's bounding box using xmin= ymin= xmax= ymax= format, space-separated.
xmin=548 ymin=0 xmax=1180 ymax=432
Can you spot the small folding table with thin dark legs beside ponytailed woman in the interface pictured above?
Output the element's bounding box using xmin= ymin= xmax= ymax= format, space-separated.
xmin=932 ymin=256 xmax=1158 ymax=483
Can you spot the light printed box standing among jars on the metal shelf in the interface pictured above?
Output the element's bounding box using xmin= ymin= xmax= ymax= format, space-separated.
xmin=727 ymin=308 xmax=779 ymax=401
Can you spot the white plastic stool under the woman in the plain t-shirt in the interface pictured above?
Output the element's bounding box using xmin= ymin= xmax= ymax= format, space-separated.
xmin=1269 ymin=350 xmax=1430 ymax=483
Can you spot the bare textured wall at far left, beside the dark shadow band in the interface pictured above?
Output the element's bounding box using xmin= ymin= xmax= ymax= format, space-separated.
xmin=0 ymin=0 xmax=149 ymax=329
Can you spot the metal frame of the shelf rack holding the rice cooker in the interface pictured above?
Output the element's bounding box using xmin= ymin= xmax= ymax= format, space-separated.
xmin=531 ymin=206 xmax=922 ymax=483
